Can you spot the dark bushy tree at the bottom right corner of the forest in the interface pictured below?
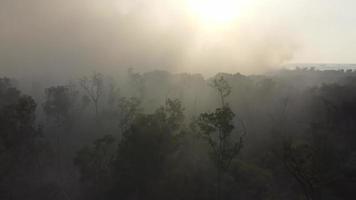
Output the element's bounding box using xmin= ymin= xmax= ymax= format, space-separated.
xmin=275 ymin=128 xmax=341 ymax=200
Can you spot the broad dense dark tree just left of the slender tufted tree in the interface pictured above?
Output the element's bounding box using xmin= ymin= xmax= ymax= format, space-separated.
xmin=114 ymin=99 xmax=184 ymax=199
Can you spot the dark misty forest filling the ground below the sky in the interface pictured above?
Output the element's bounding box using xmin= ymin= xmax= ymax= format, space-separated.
xmin=0 ymin=69 xmax=356 ymax=200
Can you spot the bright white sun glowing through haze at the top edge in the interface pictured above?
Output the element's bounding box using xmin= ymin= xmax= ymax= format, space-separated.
xmin=187 ymin=0 xmax=247 ymax=25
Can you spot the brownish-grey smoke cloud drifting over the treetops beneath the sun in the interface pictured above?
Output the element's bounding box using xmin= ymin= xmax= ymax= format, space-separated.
xmin=0 ymin=0 xmax=297 ymax=77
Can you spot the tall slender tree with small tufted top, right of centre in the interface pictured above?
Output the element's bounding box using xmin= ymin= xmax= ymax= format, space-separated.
xmin=198 ymin=76 xmax=246 ymax=200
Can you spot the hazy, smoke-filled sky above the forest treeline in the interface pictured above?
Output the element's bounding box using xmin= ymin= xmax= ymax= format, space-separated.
xmin=0 ymin=0 xmax=356 ymax=75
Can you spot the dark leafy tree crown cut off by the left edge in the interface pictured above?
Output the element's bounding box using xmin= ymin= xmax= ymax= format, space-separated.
xmin=0 ymin=79 xmax=41 ymax=167
